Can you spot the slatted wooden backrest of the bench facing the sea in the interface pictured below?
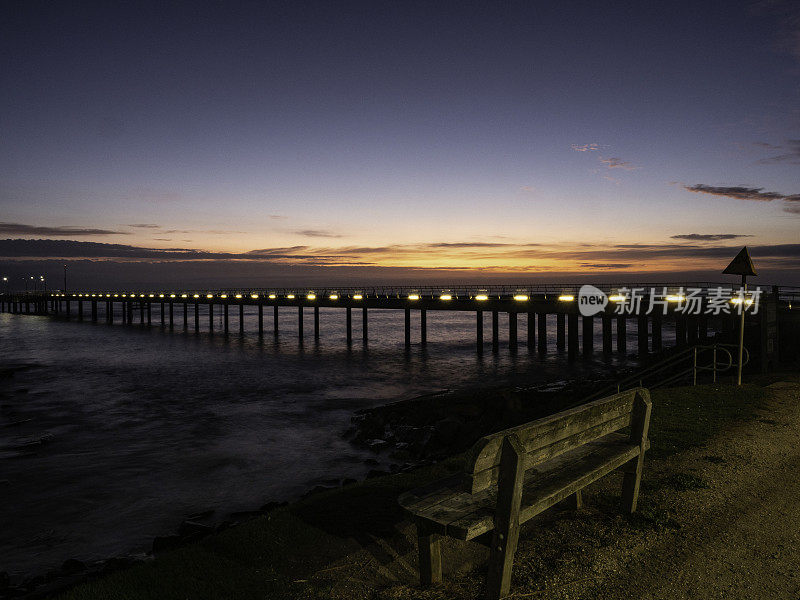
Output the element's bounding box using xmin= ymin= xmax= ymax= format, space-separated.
xmin=465 ymin=388 xmax=650 ymax=494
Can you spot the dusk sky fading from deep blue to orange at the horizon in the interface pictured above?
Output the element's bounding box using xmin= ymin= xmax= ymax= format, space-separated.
xmin=0 ymin=0 xmax=800 ymax=287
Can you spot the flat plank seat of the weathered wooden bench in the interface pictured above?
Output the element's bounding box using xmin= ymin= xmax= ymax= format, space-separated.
xmin=398 ymin=433 xmax=649 ymax=540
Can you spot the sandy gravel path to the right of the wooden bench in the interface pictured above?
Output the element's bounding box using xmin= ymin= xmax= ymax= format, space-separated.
xmin=568 ymin=384 xmax=800 ymax=600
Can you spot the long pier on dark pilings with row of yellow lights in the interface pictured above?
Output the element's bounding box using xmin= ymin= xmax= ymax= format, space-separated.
xmin=0 ymin=282 xmax=800 ymax=368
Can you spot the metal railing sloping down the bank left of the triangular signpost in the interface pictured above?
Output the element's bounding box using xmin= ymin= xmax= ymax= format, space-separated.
xmin=581 ymin=344 xmax=750 ymax=402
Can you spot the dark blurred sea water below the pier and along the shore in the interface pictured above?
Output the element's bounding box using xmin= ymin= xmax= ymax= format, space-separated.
xmin=0 ymin=306 xmax=666 ymax=573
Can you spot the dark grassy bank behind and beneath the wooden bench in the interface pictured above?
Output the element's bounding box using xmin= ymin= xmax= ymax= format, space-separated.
xmin=54 ymin=385 xmax=768 ymax=600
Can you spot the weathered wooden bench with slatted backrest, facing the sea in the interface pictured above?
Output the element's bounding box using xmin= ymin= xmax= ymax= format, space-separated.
xmin=398 ymin=388 xmax=651 ymax=600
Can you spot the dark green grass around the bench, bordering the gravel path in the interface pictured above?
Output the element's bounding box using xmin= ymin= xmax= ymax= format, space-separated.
xmin=54 ymin=385 xmax=767 ymax=600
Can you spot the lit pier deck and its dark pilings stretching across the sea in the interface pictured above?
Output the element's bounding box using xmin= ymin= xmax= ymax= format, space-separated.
xmin=0 ymin=288 xmax=756 ymax=359
